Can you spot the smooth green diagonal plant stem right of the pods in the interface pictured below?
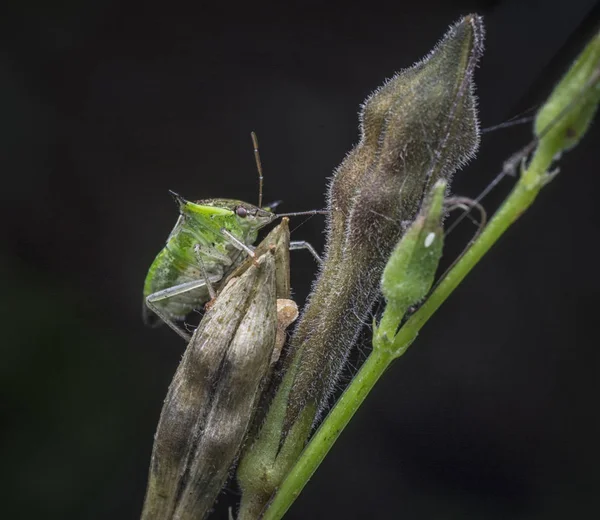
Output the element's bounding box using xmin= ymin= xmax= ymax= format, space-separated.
xmin=262 ymin=141 xmax=556 ymax=520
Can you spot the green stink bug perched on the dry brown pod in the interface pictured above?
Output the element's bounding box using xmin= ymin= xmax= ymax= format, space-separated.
xmin=143 ymin=133 xmax=322 ymax=341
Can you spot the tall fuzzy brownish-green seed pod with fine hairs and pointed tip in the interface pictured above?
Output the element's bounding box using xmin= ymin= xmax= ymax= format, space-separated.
xmin=286 ymin=15 xmax=483 ymax=431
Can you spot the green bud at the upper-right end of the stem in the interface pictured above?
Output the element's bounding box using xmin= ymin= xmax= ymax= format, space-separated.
xmin=534 ymin=29 xmax=600 ymax=152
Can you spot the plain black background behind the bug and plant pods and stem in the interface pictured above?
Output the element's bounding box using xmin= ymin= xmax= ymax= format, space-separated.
xmin=0 ymin=0 xmax=600 ymax=519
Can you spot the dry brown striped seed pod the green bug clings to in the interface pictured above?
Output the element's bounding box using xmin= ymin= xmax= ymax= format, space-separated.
xmin=142 ymin=219 xmax=298 ymax=520
